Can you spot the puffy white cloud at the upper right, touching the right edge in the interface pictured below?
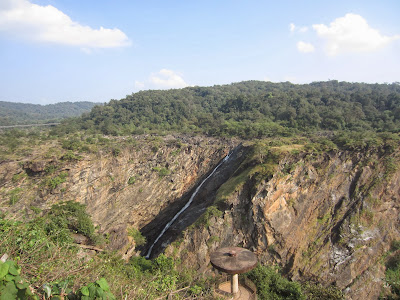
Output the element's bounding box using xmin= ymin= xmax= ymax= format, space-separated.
xmin=312 ymin=13 xmax=400 ymax=56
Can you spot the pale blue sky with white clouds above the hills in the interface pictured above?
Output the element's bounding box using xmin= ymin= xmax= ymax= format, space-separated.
xmin=0 ymin=0 xmax=400 ymax=104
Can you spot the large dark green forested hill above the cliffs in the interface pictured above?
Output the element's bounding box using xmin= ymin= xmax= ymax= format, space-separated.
xmin=60 ymin=81 xmax=400 ymax=138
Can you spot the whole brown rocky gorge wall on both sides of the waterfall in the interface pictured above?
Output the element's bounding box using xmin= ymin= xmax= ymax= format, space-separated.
xmin=0 ymin=136 xmax=400 ymax=299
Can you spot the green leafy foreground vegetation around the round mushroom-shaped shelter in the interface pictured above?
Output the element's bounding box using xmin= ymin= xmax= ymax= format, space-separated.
xmin=0 ymin=202 xmax=341 ymax=300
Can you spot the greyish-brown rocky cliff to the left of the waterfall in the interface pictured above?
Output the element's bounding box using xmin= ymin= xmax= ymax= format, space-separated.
xmin=0 ymin=136 xmax=234 ymax=256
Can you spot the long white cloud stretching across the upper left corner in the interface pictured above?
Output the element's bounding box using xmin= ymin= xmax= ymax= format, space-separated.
xmin=0 ymin=0 xmax=131 ymax=48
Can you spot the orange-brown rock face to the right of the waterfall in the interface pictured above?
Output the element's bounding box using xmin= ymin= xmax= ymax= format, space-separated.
xmin=166 ymin=150 xmax=400 ymax=299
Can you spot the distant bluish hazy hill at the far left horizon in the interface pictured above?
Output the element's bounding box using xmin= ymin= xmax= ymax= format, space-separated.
xmin=0 ymin=101 xmax=99 ymax=126
